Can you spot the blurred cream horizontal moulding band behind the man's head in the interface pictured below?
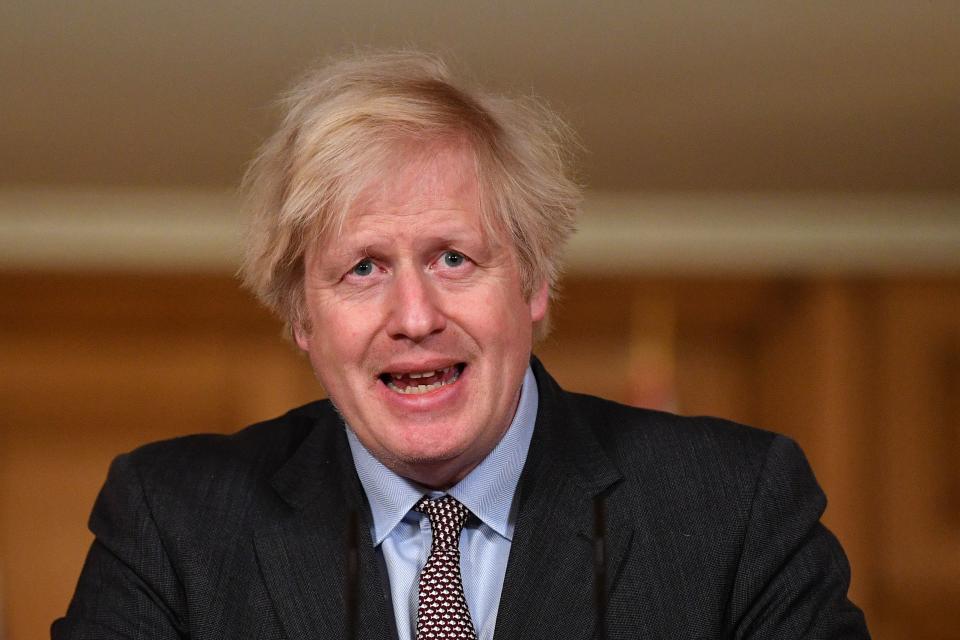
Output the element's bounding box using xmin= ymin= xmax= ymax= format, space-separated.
xmin=0 ymin=187 xmax=960 ymax=276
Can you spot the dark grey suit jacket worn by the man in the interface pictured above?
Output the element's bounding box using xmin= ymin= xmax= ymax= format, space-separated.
xmin=52 ymin=360 xmax=868 ymax=640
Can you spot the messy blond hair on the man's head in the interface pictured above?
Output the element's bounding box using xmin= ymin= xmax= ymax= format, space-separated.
xmin=240 ymin=52 xmax=581 ymax=339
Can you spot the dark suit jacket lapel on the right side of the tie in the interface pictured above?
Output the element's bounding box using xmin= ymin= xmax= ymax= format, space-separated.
xmin=495 ymin=360 xmax=633 ymax=640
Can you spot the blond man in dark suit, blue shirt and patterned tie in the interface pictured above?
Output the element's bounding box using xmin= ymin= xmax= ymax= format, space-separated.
xmin=53 ymin=54 xmax=867 ymax=640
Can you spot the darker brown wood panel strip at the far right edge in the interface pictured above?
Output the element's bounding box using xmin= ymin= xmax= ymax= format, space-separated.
xmin=876 ymin=281 xmax=960 ymax=639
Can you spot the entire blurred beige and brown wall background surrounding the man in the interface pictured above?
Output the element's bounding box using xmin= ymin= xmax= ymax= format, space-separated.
xmin=0 ymin=0 xmax=960 ymax=640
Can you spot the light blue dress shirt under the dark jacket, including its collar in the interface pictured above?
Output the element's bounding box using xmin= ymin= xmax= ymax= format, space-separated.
xmin=347 ymin=367 xmax=539 ymax=640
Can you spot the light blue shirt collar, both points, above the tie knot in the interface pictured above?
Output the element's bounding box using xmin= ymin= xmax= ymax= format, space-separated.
xmin=347 ymin=367 xmax=539 ymax=545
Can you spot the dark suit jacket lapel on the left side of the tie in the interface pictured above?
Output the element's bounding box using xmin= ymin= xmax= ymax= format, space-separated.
xmin=255 ymin=407 xmax=394 ymax=640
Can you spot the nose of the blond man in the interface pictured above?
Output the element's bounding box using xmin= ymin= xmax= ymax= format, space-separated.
xmin=386 ymin=267 xmax=447 ymax=342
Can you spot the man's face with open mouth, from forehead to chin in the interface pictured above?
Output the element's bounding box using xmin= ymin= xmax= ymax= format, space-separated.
xmin=296 ymin=144 xmax=547 ymax=487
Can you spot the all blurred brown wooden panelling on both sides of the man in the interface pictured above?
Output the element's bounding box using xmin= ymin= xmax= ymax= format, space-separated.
xmin=0 ymin=274 xmax=960 ymax=640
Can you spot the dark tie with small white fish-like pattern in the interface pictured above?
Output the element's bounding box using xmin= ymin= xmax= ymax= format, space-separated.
xmin=414 ymin=496 xmax=477 ymax=640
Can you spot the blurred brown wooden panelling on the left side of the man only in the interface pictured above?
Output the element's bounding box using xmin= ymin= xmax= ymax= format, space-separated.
xmin=0 ymin=276 xmax=321 ymax=640
